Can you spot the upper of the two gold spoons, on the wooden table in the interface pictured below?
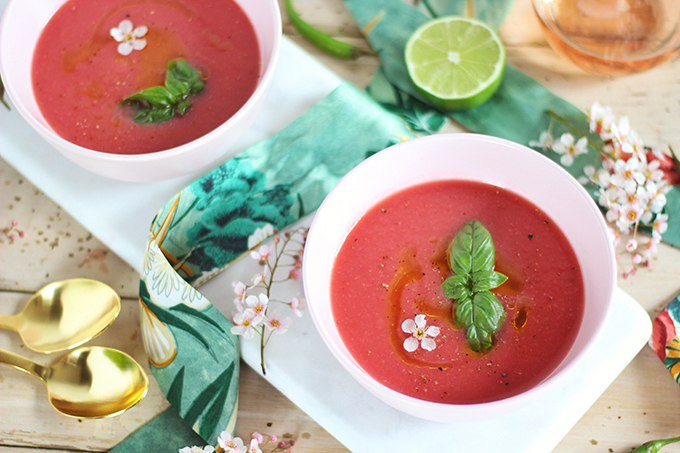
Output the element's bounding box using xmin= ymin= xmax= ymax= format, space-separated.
xmin=0 ymin=278 xmax=121 ymax=354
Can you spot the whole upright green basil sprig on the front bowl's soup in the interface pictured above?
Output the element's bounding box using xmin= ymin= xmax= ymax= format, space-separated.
xmin=442 ymin=220 xmax=508 ymax=352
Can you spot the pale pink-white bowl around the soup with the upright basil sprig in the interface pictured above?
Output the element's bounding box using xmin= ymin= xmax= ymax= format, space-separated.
xmin=303 ymin=134 xmax=616 ymax=422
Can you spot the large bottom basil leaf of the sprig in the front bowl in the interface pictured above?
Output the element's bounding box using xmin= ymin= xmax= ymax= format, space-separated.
xmin=455 ymin=291 xmax=505 ymax=352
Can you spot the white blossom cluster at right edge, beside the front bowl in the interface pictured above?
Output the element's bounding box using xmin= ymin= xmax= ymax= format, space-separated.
xmin=529 ymin=103 xmax=680 ymax=278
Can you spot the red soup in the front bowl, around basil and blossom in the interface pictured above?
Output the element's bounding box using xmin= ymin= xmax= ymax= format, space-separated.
xmin=331 ymin=181 xmax=584 ymax=404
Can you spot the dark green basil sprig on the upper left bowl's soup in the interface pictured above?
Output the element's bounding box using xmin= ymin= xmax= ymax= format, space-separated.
xmin=121 ymin=59 xmax=205 ymax=124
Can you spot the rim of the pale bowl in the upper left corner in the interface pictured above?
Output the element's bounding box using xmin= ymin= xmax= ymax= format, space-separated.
xmin=0 ymin=0 xmax=283 ymax=164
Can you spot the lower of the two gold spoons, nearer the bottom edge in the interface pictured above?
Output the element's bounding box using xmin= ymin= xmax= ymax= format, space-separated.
xmin=0 ymin=346 xmax=149 ymax=418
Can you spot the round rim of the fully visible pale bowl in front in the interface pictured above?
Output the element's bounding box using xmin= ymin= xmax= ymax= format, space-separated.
xmin=302 ymin=133 xmax=617 ymax=422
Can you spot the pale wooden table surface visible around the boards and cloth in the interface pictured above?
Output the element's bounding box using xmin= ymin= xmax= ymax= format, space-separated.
xmin=0 ymin=0 xmax=680 ymax=453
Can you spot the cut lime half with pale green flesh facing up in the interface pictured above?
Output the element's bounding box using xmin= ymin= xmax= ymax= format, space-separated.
xmin=404 ymin=16 xmax=505 ymax=110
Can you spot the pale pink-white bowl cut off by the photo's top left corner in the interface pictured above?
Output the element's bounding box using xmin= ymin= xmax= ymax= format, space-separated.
xmin=0 ymin=0 xmax=281 ymax=182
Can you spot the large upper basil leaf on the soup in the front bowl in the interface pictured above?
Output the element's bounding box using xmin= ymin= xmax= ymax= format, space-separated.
xmin=449 ymin=220 xmax=496 ymax=274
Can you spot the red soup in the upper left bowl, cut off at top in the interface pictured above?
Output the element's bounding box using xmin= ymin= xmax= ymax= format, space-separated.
xmin=32 ymin=0 xmax=260 ymax=154
